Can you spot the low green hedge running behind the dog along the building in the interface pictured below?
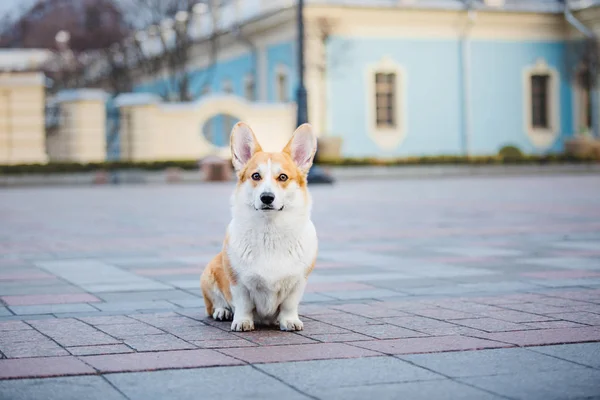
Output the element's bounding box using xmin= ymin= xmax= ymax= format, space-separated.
xmin=0 ymin=154 xmax=597 ymax=175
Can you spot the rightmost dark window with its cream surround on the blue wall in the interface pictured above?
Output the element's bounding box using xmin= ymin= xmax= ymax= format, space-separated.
xmin=523 ymin=59 xmax=560 ymax=149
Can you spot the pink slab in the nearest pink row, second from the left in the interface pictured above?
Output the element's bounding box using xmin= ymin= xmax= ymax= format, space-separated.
xmin=80 ymin=349 xmax=243 ymax=373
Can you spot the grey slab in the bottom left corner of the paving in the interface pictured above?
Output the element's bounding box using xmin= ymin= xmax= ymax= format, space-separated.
xmin=0 ymin=376 xmax=126 ymax=400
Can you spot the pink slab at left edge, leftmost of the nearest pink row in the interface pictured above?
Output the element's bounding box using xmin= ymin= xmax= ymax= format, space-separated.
xmin=0 ymin=356 xmax=96 ymax=379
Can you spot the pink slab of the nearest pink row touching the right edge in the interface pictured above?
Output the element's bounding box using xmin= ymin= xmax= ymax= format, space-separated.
xmin=477 ymin=326 xmax=600 ymax=346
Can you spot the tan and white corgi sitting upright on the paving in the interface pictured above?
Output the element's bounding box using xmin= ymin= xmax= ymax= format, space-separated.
xmin=200 ymin=122 xmax=317 ymax=331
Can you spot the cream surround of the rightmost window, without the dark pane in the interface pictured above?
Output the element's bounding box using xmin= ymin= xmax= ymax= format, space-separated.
xmin=523 ymin=59 xmax=560 ymax=149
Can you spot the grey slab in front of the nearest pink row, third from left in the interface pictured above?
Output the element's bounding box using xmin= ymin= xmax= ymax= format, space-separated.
xmin=257 ymin=357 xmax=444 ymax=395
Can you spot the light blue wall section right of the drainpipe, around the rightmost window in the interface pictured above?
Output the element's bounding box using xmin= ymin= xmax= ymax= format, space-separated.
xmin=471 ymin=41 xmax=573 ymax=154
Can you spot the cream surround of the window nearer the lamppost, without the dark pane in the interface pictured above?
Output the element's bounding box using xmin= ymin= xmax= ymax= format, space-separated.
xmin=365 ymin=57 xmax=408 ymax=150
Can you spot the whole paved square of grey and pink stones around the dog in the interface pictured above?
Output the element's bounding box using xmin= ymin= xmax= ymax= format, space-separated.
xmin=0 ymin=176 xmax=600 ymax=400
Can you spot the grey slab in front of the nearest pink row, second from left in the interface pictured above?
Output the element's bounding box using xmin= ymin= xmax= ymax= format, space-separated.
xmin=106 ymin=366 xmax=308 ymax=400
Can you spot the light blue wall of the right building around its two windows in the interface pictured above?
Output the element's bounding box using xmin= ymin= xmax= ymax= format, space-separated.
xmin=327 ymin=36 xmax=573 ymax=157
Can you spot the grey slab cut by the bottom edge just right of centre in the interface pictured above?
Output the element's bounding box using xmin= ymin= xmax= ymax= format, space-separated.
xmin=315 ymin=380 xmax=505 ymax=400
